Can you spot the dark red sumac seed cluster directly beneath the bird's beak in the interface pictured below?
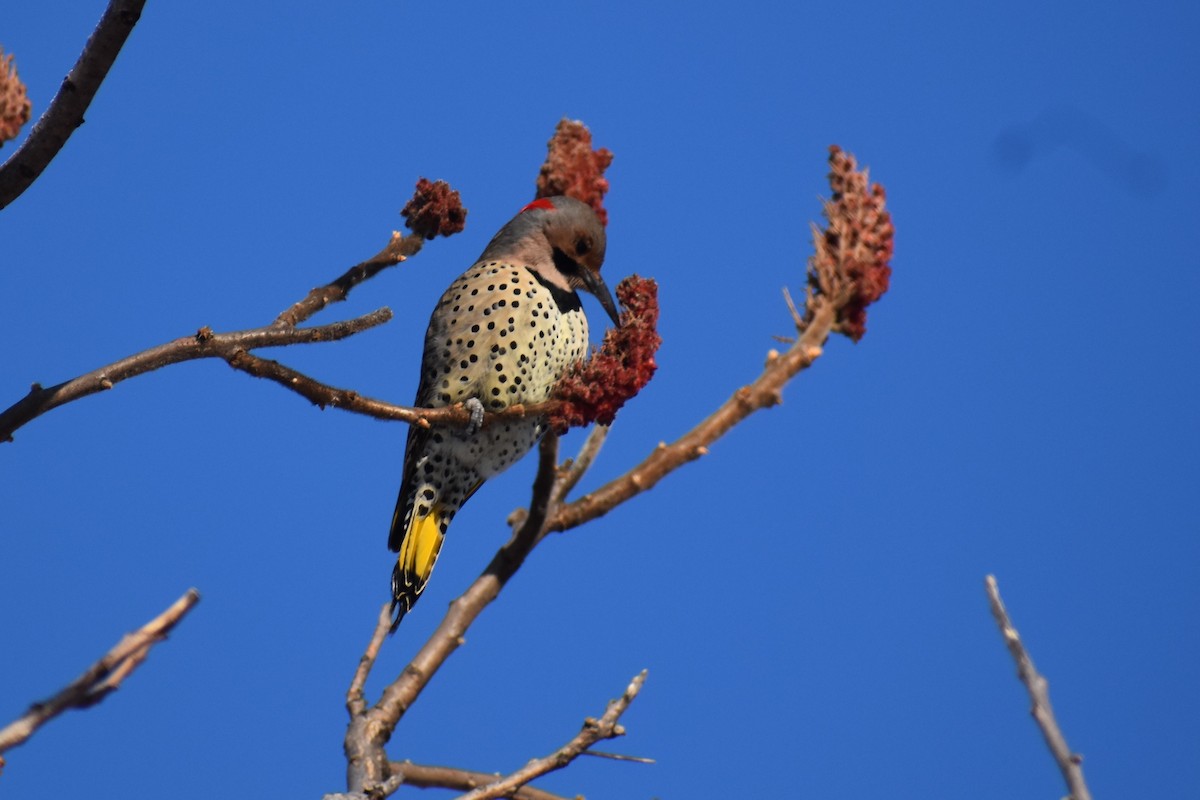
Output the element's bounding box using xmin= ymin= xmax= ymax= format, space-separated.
xmin=550 ymin=275 xmax=662 ymax=433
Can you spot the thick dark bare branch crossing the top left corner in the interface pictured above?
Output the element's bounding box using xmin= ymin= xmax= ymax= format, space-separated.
xmin=0 ymin=0 xmax=145 ymax=209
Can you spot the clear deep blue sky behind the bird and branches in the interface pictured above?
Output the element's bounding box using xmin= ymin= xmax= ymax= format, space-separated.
xmin=0 ymin=0 xmax=1200 ymax=800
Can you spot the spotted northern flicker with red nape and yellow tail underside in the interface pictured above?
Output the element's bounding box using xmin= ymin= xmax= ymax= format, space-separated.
xmin=388 ymin=197 xmax=618 ymax=630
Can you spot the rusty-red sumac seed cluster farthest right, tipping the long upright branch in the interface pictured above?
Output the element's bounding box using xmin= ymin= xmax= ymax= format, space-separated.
xmin=809 ymin=145 xmax=895 ymax=342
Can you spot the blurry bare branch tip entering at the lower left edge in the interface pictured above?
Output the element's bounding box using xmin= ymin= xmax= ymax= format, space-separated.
xmin=0 ymin=589 xmax=200 ymax=766
